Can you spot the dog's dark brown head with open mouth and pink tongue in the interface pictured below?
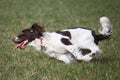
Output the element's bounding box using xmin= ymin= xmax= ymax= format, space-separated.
xmin=13 ymin=23 xmax=45 ymax=49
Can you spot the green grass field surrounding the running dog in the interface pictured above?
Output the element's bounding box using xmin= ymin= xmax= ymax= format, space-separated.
xmin=0 ymin=0 xmax=120 ymax=80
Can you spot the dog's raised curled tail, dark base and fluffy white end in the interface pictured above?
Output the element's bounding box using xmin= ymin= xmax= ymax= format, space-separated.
xmin=97 ymin=17 xmax=113 ymax=41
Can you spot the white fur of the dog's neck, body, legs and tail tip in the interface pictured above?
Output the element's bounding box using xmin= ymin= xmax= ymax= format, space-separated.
xmin=29 ymin=17 xmax=111 ymax=63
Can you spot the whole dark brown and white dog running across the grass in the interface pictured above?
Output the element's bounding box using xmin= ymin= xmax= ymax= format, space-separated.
xmin=13 ymin=17 xmax=112 ymax=63
